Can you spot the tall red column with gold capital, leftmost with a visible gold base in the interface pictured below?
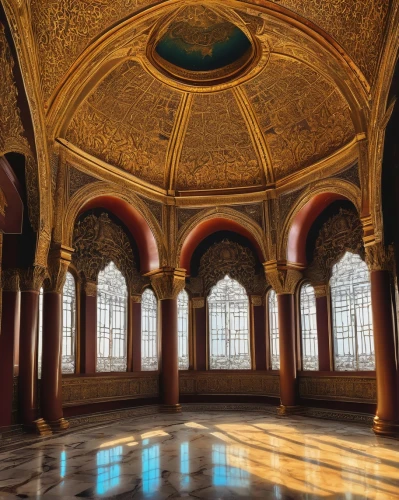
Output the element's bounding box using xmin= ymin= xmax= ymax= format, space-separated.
xmin=18 ymin=266 xmax=51 ymax=435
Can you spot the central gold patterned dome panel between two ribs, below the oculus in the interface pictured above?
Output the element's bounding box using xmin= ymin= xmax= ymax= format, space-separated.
xmin=176 ymin=90 xmax=262 ymax=190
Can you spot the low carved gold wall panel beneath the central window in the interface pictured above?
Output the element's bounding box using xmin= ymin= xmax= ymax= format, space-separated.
xmin=179 ymin=371 xmax=280 ymax=397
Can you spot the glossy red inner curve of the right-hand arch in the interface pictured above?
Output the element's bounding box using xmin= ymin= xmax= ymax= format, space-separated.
xmin=287 ymin=193 xmax=350 ymax=266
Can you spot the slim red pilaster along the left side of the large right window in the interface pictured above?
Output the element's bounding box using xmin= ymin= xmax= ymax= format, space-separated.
xmin=313 ymin=284 xmax=331 ymax=371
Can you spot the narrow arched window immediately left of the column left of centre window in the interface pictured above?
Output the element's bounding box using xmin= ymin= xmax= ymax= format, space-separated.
xmin=141 ymin=288 xmax=158 ymax=371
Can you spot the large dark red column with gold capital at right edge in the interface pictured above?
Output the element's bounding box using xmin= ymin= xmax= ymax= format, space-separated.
xmin=366 ymin=244 xmax=399 ymax=436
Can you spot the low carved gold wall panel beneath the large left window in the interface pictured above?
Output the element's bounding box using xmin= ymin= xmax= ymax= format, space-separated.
xmin=62 ymin=373 xmax=159 ymax=406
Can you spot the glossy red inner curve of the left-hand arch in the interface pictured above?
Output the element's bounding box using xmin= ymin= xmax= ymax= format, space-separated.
xmin=78 ymin=196 xmax=159 ymax=274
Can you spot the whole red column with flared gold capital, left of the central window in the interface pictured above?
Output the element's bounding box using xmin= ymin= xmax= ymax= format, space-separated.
xmin=149 ymin=267 xmax=185 ymax=413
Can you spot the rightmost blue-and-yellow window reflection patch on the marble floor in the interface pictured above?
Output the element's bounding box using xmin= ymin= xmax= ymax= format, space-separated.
xmin=212 ymin=444 xmax=249 ymax=488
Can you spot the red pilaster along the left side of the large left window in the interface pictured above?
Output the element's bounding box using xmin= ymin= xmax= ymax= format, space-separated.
xmin=80 ymin=281 xmax=97 ymax=373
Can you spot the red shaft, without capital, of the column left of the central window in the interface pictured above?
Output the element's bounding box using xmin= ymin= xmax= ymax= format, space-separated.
xmin=161 ymin=299 xmax=181 ymax=412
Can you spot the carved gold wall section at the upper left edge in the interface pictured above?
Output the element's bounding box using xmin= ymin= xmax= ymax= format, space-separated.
xmin=0 ymin=23 xmax=29 ymax=155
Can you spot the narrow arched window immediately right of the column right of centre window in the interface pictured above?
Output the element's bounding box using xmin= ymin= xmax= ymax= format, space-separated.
xmin=300 ymin=283 xmax=319 ymax=370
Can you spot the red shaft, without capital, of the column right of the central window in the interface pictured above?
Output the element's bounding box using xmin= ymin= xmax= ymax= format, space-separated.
xmin=277 ymin=293 xmax=297 ymax=414
